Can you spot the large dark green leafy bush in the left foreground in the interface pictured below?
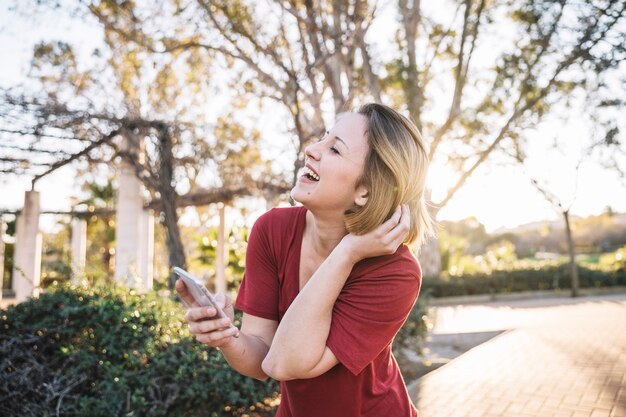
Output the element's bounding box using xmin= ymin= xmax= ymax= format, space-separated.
xmin=0 ymin=287 xmax=278 ymax=417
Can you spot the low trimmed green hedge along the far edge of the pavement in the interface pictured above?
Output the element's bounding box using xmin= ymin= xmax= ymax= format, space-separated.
xmin=423 ymin=264 xmax=626 ymax=297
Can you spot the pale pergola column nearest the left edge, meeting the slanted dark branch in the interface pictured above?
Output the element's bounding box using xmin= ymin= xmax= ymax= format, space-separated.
xmin=12 ymin=191 xmax=42 ymax=303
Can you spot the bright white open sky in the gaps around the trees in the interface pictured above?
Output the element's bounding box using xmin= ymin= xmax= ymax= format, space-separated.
xmin=0 ymin=2 xmax=626 ymax=231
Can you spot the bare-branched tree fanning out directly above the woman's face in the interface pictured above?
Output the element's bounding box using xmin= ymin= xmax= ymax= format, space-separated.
xmin=77 ymin=0 xmax=375 ymax=186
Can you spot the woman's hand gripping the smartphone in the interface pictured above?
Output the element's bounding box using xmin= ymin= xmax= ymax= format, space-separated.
xmin=176 ymin=279 xmax=239 ymax=347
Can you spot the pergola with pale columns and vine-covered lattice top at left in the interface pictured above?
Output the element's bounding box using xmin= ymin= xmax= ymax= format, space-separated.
xmin=0 ymin=94 xmax=292 ymax=302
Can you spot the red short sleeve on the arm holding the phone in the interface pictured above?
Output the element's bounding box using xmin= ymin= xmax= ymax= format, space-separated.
xmin=235 ymin=213 xmax=278 ymax=321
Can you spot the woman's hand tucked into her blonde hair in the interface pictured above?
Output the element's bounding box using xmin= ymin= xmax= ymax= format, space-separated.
xmin=339 ymin=204 xmax=411 ymax=263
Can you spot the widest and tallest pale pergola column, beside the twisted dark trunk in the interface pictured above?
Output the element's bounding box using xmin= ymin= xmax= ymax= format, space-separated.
xmin=115 ymin=154 xmax=143 ymax=288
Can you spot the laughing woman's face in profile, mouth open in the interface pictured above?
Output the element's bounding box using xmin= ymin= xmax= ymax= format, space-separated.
xmin=291 ymin=113 xmax=369 ymax=214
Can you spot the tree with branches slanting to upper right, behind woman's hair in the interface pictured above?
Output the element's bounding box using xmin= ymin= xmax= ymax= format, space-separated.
xmin=392 ymin=0 xmax=626 ymax=202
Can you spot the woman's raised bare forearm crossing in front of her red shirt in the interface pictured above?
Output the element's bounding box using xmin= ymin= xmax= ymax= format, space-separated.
xmin=263 ymin=245 xmax=354 ymax=379
